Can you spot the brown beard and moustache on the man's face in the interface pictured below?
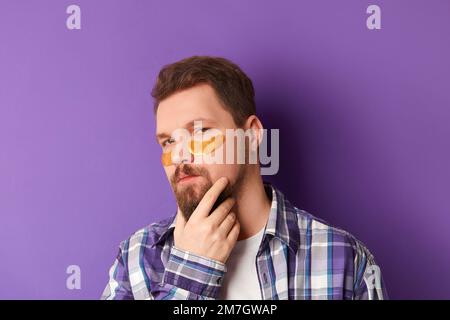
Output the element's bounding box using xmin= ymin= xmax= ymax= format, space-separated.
xmin=170 ymin=164 xmax=245 ymax=222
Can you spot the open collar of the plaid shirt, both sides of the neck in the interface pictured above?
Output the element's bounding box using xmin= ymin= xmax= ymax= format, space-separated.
xmin=152 ymin=182 xmax=300 ymax=253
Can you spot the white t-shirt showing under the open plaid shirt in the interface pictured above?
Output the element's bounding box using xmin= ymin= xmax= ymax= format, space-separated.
xmin=219 ymin=227 xmax=264 ymax=300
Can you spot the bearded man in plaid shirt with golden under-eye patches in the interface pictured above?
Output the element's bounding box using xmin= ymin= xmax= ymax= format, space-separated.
xmin=102 ymin=56 xmax=386 ymax=300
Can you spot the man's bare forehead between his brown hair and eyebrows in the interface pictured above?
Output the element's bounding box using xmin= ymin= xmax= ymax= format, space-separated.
xmin=156 ymin=84 xmax=233 ymax=134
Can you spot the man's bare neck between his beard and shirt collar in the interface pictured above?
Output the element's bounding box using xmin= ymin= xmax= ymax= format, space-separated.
xmin=233 ymin=166 xmax=271 ymax=241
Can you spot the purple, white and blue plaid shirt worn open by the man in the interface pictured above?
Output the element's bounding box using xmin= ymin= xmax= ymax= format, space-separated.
xmin=101 ymin=183 xmax=387 ymax=300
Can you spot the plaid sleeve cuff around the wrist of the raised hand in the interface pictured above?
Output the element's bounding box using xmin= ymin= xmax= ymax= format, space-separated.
xmin=162 ymin=246 xmax=227 ymax=300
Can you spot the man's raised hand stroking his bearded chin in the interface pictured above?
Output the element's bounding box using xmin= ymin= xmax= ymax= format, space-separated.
xmin=174 ymin=177 xmax=240 ymax=263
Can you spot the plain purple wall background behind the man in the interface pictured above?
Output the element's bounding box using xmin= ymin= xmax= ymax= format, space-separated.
xmin=0 ymin=0 xmax=450 ymax=299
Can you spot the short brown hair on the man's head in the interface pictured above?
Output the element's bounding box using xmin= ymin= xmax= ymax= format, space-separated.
xmin=152 ymin=56 xmax=256 ymax=126
